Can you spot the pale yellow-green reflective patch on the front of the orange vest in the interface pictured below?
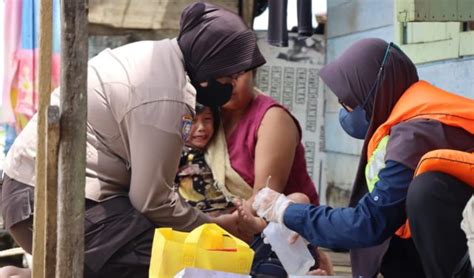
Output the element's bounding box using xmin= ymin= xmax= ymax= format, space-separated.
xmin=365 ymin=135 xmax=390 ymax=192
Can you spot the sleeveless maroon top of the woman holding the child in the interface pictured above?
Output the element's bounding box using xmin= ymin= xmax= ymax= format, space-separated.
xmin=226 ymin=95 xmax=319 ymax=205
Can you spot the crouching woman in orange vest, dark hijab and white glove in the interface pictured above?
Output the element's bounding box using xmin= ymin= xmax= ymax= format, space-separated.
xmin=253 ymin=39 xmax=474 ymax=278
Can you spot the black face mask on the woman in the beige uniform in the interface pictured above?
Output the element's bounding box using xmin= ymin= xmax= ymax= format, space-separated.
xmin=194 ymin=79 xmax=234 ymax=107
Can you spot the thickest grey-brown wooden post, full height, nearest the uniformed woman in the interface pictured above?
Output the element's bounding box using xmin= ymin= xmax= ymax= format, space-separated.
xmin=56 ymin=0 xmax=88 ymax=278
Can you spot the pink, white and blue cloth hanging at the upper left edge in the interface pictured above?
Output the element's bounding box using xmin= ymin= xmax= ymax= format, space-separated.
xmin=2 ymin=0 xmax=60 ymax=132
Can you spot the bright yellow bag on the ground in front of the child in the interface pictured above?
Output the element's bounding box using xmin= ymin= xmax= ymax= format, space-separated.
xmin=149 ymin=224 xmax=254 ymax=278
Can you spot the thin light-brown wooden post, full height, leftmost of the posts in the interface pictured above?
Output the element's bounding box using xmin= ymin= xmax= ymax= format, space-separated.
xmin=32 ymin=0 xmax=53 ymax=278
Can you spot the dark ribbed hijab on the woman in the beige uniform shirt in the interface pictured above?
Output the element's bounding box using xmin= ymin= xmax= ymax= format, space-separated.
xmin=178 ymin=3 xmax=266 ymax=83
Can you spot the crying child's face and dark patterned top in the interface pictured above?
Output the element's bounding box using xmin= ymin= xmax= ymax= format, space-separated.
xmin=175 ymin=104 xmax=233 ymax=213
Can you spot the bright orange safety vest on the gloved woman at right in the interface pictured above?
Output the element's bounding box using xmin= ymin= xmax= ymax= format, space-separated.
xmin=367 ymin=81 xmax=474 ymax=238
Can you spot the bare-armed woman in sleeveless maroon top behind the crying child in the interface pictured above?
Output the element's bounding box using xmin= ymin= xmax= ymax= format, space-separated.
xmin=221 ymin=71 xmax=319 ymax=204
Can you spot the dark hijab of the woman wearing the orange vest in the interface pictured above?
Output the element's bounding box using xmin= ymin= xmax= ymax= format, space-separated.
xmin=320 ymin=39 xmax=418 ymax=206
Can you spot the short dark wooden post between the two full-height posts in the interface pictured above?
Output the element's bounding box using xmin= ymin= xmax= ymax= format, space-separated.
xmin=44 ymin=106 xmax=60 ymax=278
